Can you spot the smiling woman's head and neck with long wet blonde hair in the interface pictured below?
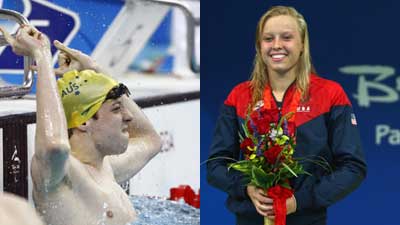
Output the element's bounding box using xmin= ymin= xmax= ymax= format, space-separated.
xmin=251 ymin=7 xmax=316 ymax=106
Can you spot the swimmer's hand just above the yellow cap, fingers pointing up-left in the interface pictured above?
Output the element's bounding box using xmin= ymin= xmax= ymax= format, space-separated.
xmin=53 ymin=40 xmax=99 ymax=75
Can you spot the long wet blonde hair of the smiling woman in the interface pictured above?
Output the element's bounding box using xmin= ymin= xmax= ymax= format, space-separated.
xmin=250 ymin=6 xmax=315 ymax=108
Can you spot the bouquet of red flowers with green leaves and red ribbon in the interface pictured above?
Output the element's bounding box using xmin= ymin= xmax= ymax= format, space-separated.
xmin=229 ymin=108 xmax=308 ymax=225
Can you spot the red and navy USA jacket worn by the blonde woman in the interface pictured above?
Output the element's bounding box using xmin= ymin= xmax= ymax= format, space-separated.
xmin=207 ymin=74 xmax=367 ymax=225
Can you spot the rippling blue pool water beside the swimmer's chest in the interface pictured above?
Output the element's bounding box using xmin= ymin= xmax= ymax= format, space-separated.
xmin=127 ymin=196 xmax=200 ymax=225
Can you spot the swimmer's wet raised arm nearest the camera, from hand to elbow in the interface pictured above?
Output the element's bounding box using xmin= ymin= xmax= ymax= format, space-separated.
xmin=2 ymin=26 xmax=70 ymax=191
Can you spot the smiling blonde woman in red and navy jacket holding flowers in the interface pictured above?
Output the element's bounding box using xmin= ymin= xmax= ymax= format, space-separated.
xmin=207 ymin=6 xmax=366 ymax=225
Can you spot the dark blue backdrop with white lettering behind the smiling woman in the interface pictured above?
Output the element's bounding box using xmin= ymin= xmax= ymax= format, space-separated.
xmin=201 ymin=0 xmax=400 ymax=225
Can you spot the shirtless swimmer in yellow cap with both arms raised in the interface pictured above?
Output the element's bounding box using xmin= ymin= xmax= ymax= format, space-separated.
xmin=3 ymin=26 xmax=160 ymax=225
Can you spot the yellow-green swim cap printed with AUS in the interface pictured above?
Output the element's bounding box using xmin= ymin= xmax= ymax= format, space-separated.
xmin=57 ymin=70 xmax=118 ymax=128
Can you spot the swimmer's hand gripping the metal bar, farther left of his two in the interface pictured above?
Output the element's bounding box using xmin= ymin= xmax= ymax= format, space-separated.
xmin=0 ymin=25 xmax=50 ymax=59
